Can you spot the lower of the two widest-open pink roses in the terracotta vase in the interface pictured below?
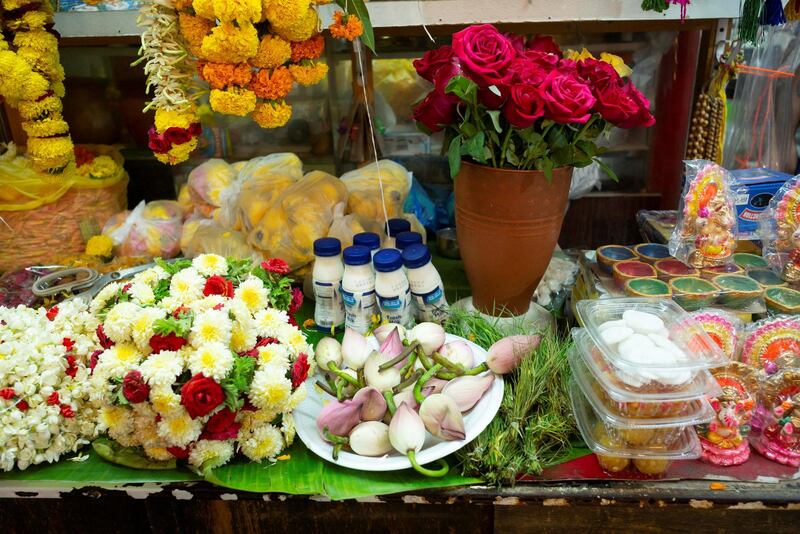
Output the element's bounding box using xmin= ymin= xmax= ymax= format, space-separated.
xmin=542 ymin=71 xmax=596 ymax=124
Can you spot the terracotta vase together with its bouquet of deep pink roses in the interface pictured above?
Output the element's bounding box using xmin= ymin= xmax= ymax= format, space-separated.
xmin=414 ymin=24 xmax=655 ymax=315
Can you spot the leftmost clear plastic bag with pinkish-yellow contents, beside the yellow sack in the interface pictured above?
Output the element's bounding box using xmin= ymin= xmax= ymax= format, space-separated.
xmin=103 ymin=200 xmax=183 ymax=258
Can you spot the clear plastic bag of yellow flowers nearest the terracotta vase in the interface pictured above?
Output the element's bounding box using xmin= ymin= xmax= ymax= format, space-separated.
xmin=341 ymin=159 xmax=412 ymax=221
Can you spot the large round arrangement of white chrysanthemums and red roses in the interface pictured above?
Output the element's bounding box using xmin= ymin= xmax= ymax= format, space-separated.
xmin=89 ymin=254 xmax=314 ymax=471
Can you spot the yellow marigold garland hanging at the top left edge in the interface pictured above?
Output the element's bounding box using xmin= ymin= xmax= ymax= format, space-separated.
xmin=0 ymin=0 xmax=73 ymax=174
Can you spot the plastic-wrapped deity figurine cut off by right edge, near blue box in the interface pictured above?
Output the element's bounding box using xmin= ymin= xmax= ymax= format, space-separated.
xmin=759 ymin=176 xmax=800 ymax=284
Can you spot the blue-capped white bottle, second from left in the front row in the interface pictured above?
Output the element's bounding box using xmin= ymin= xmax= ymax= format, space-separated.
xmin=342 ymin=245 xmax=378 ymax=334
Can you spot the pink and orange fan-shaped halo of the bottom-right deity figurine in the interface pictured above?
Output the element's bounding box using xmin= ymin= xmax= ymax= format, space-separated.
xmin=739 ymin=315 xmax=800 ymax=369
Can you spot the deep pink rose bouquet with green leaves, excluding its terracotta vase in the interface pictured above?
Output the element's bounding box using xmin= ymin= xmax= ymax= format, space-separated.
xmin=414 ymin=24 xmax=655 ymax=178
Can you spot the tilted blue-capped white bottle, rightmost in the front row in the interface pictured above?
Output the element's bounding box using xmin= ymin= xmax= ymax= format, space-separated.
xmin=403 ymin=244 xmax=447 ymax=323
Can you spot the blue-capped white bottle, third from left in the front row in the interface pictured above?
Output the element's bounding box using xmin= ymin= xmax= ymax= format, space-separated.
xmin=372 ymin=248 xmax=414 ymax=328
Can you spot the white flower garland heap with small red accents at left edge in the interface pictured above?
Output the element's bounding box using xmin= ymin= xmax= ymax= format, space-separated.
xmin=0 ymin=301 xmax=97 ymax=471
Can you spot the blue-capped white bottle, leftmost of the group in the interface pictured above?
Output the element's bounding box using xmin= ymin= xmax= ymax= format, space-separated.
xmin=311 ymin=237 xmax=344 ymax=332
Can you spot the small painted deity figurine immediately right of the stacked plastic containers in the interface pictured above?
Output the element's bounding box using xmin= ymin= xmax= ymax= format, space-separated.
xmin=697 ymin=362 xmax=759 ymax=465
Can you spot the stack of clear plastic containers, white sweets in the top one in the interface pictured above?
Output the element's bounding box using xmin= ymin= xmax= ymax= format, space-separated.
xmin=569 ymin=298 xmax=727 ymax=475
